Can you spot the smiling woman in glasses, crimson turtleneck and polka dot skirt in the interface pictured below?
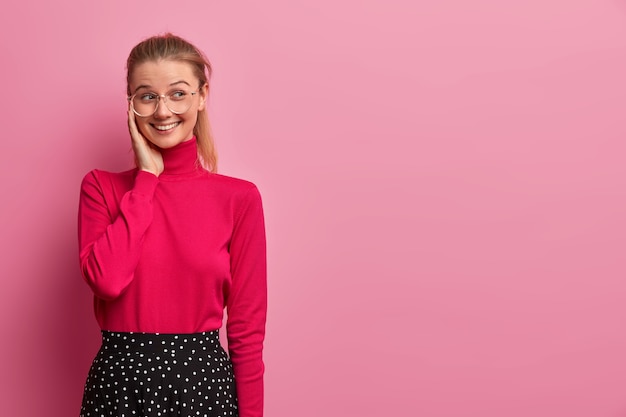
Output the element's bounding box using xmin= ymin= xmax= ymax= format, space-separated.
xmin=78 ymin=34 xmax=267 ymax=417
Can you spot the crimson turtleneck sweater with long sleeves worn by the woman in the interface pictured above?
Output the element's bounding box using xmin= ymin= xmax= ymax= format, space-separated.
xmin=78 ymin=139 xmax=267 ymax=417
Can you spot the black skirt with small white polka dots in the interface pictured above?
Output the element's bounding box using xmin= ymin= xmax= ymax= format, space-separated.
xmin=80 ymin=330 xmax=238 ymax=417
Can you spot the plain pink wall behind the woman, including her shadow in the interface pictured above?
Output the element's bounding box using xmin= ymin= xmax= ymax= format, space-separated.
xmin=0 ymin=0 xmax=626 ymax=417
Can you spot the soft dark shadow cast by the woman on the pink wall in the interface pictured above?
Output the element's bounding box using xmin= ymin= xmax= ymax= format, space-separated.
xmin=28 ymin=108 xmax=132 ymax=417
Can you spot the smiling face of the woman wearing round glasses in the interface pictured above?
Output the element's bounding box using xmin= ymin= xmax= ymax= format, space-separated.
xmin=130 ymin=60 xmax=208 ymax=149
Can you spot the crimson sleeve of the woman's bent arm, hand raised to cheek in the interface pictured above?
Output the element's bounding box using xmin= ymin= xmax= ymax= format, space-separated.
xmin=78 ymin=170 xmax=158 ymax=300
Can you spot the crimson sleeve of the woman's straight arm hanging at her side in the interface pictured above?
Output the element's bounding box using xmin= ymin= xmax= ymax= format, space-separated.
xmin=226 ymin=187 xmax=267 ymax=417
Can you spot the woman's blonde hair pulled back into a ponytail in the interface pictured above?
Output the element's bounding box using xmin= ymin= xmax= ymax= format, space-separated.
xmin=126 ymin=33 xmax=217 ymax=172
